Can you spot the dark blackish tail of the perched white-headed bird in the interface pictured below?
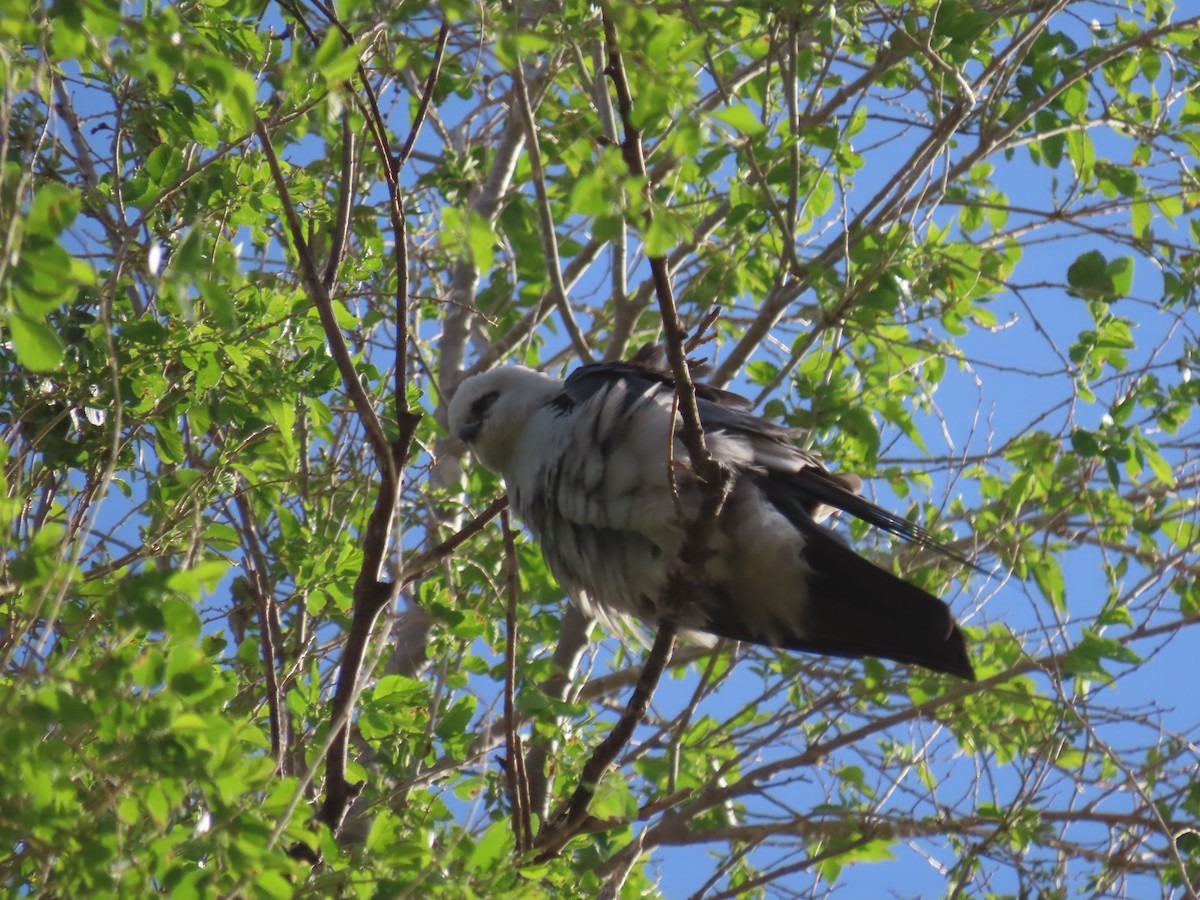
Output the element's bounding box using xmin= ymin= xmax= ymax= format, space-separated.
xmin=785 ymin=516 xmax=974 ymax=680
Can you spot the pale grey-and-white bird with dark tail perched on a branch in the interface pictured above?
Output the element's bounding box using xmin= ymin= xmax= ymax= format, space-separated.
xmin=448 ymin=344 xmax=974 ymax=680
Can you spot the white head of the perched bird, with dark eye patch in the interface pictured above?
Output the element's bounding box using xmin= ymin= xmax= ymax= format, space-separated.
xmin=449 ymin=366 xmax=563 ymax=474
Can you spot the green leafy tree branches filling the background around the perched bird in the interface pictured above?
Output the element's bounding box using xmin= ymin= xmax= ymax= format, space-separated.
xmin=0 ymin=0 xmax=1200 ymax=898
